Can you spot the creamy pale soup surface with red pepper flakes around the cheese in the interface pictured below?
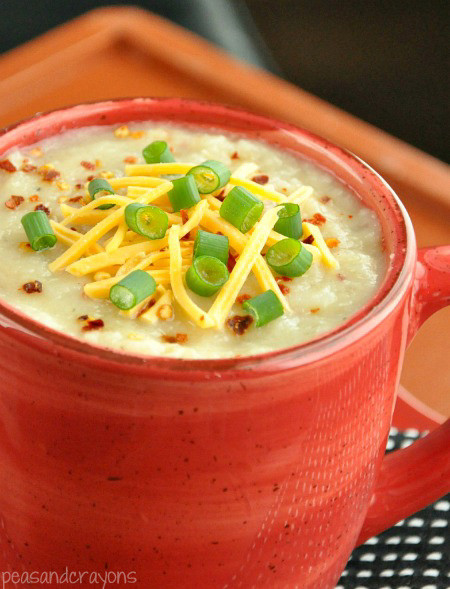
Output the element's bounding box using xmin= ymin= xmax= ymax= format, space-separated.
xmin=0 ymin=124 xmax=386 ymax=358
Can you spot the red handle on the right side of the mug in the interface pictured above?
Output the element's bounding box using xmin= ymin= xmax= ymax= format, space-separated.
xmin=356 ymin=245 xmax=450 ymax=545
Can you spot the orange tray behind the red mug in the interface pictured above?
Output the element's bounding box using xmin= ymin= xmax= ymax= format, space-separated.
xmin=0 ymin=7 xmax=450 ymax=427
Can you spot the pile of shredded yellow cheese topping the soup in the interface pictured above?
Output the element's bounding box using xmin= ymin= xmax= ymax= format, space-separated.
xmin=49 ymin=162 xmax=338 ymax=329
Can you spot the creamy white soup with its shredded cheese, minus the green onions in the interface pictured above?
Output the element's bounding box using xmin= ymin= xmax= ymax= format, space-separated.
xmin=0 ymin=124 xmax=386 ymax=358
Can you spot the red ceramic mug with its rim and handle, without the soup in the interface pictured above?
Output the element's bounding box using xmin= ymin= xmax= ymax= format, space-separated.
xmin=0 ymin=99 xmax=450 ymax=589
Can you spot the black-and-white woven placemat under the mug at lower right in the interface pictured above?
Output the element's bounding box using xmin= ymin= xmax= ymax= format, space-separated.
xmin=336 ymin=428 xmax=450 ymax=589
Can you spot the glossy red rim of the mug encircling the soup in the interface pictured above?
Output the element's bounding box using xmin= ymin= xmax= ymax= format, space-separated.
xmin=0 ymin=97 xmax=417 ymax=375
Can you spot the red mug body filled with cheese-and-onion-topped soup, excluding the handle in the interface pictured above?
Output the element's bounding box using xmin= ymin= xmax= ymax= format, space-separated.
xmin=0 ymin=99 xmax=448 ymax=589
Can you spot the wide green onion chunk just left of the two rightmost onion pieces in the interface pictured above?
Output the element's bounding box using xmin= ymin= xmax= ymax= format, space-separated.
xmin=219 ymin=186 xmax=264 ymax=233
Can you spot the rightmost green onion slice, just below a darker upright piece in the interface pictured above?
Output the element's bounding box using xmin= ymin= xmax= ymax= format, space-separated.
xmin=266 ymin=237 xmax=313 ymax=277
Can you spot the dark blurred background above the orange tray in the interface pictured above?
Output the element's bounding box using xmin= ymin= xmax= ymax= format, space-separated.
xmin=0 ymin=0 xmax=450 ymax=160
